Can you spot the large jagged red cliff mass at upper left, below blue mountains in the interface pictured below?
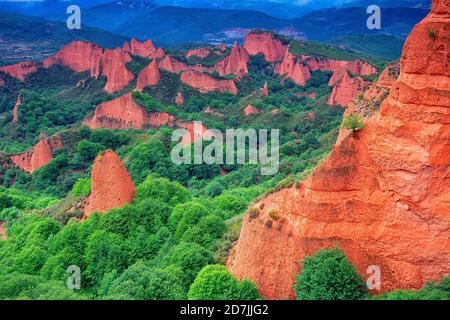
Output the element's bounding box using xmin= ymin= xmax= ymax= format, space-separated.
xmin=43 ymin=41 xmax=134 ymax=93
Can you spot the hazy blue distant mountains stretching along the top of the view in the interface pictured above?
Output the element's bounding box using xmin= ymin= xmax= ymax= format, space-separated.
xmin=0 ymin=0 xmax=429 ymax=63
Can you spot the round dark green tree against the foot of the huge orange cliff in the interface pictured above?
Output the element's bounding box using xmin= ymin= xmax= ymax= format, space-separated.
xmin=294 ymin=249 xmax=364 ymax=300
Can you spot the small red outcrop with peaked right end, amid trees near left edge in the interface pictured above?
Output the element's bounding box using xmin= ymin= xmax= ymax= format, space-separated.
xmin=11 ymin=140 xmax=53 ymax=173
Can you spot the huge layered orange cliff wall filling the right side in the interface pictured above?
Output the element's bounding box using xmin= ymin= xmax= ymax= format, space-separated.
xmin=228 ymin=0 xmax=450 ymax=299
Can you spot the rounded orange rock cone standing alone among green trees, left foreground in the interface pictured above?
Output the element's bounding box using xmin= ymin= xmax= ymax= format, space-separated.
xmin=85 ymin=150 xmax=136 ymax=218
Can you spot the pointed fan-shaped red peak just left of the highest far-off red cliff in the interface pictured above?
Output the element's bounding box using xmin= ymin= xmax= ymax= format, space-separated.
xmin=213 ymin=42 xmax=250 ymax=78
